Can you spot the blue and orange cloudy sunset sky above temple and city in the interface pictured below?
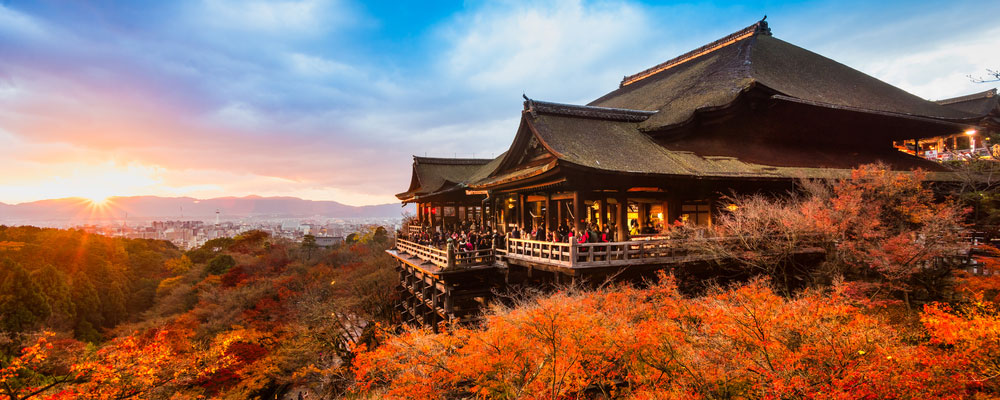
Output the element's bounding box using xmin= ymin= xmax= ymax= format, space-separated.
xmin=0 ymin=0 xmax=1000 ymax=205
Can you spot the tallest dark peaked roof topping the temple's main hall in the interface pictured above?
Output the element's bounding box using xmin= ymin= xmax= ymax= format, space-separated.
xmin=588 ymin=20 xmax=975 ymax=131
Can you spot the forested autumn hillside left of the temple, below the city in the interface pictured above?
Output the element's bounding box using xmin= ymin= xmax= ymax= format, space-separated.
xmin=0 ymin=227 xmax=398 ymax=400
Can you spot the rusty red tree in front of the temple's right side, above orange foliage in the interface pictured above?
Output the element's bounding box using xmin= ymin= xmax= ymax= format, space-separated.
xmin=701 ymin=164 xmax=968 ymax=306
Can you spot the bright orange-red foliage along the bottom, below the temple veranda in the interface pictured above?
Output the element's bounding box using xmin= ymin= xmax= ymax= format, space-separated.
xmin=354 ymin=279 xmax=1000 ymax=399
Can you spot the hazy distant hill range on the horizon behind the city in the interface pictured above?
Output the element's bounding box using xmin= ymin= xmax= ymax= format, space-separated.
xmin=0 ymin=196 xmax=403 ymax=224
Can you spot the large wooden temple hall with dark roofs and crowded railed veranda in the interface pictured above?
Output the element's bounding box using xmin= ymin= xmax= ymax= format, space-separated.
xmin=390 ymin=20 xmax=985 ymax=324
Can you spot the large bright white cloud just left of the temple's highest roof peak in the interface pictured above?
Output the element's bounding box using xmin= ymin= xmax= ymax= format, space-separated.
xmin=441 ymin=0 xmax=657 ymax=97
